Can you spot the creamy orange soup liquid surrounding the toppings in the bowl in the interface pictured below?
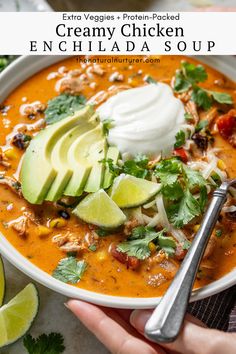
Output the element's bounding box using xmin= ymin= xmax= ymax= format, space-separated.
xmin=0 ymin=56 xmax=236 ymax=297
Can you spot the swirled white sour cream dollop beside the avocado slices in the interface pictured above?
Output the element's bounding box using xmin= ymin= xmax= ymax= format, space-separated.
xmin=98 ymin=83 xmax=185 ymax=156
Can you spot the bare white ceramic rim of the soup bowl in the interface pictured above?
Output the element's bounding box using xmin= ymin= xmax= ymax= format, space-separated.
xmin=0 ymin=56 xmax=236 ymax=309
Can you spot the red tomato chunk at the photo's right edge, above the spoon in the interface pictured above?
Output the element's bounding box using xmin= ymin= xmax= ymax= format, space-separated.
xmin=217 ymin=109 xmax=236 ymax=142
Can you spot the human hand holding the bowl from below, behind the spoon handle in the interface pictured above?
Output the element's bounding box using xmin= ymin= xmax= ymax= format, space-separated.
xmin=66 ymin=300 xmax=236 ymax=354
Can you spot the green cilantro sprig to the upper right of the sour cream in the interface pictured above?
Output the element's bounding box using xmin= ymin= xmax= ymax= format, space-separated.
xmin=174 ymin=62 xmax=233 ymax=110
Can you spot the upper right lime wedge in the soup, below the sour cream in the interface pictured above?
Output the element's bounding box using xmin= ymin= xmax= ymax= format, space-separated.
xmin=110 ymin=174 xmax=161 ymax=208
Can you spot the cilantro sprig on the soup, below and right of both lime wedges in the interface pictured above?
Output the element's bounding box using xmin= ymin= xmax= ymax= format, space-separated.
xmin=117 ymin=226 xmax=176 ymax=260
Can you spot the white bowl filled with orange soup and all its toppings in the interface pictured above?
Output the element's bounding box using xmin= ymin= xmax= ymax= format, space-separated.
xmin=0 ymin=56 xmax=236 ymax=308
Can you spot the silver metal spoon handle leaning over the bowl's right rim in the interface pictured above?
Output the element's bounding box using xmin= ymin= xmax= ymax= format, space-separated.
xmin=145 ymin=179 xmax=236 ymax=343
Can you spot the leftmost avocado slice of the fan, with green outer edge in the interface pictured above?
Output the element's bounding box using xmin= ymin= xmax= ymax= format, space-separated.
xmin=20 ymin=106 xmax=93 ymax=204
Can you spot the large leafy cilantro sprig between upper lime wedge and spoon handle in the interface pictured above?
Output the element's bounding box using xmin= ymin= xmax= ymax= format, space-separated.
xmin=155 ymin=157 xmax=207 ymax=228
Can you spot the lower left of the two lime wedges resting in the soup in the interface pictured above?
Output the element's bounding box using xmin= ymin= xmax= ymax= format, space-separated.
xmin=73 ymin=189 xmax=126 ymax=229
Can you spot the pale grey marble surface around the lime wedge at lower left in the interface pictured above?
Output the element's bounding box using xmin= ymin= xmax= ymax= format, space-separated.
xmin=0 ymin=261 xmax=108 ymax=354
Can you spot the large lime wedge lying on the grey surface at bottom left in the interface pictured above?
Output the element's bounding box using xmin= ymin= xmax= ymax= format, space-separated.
xmin=0 ymin=284 xmax=39 ymax=348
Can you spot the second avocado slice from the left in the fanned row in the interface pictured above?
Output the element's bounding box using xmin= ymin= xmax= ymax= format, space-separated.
xmin=45 ymin=117 xmax=98 ymax=202
